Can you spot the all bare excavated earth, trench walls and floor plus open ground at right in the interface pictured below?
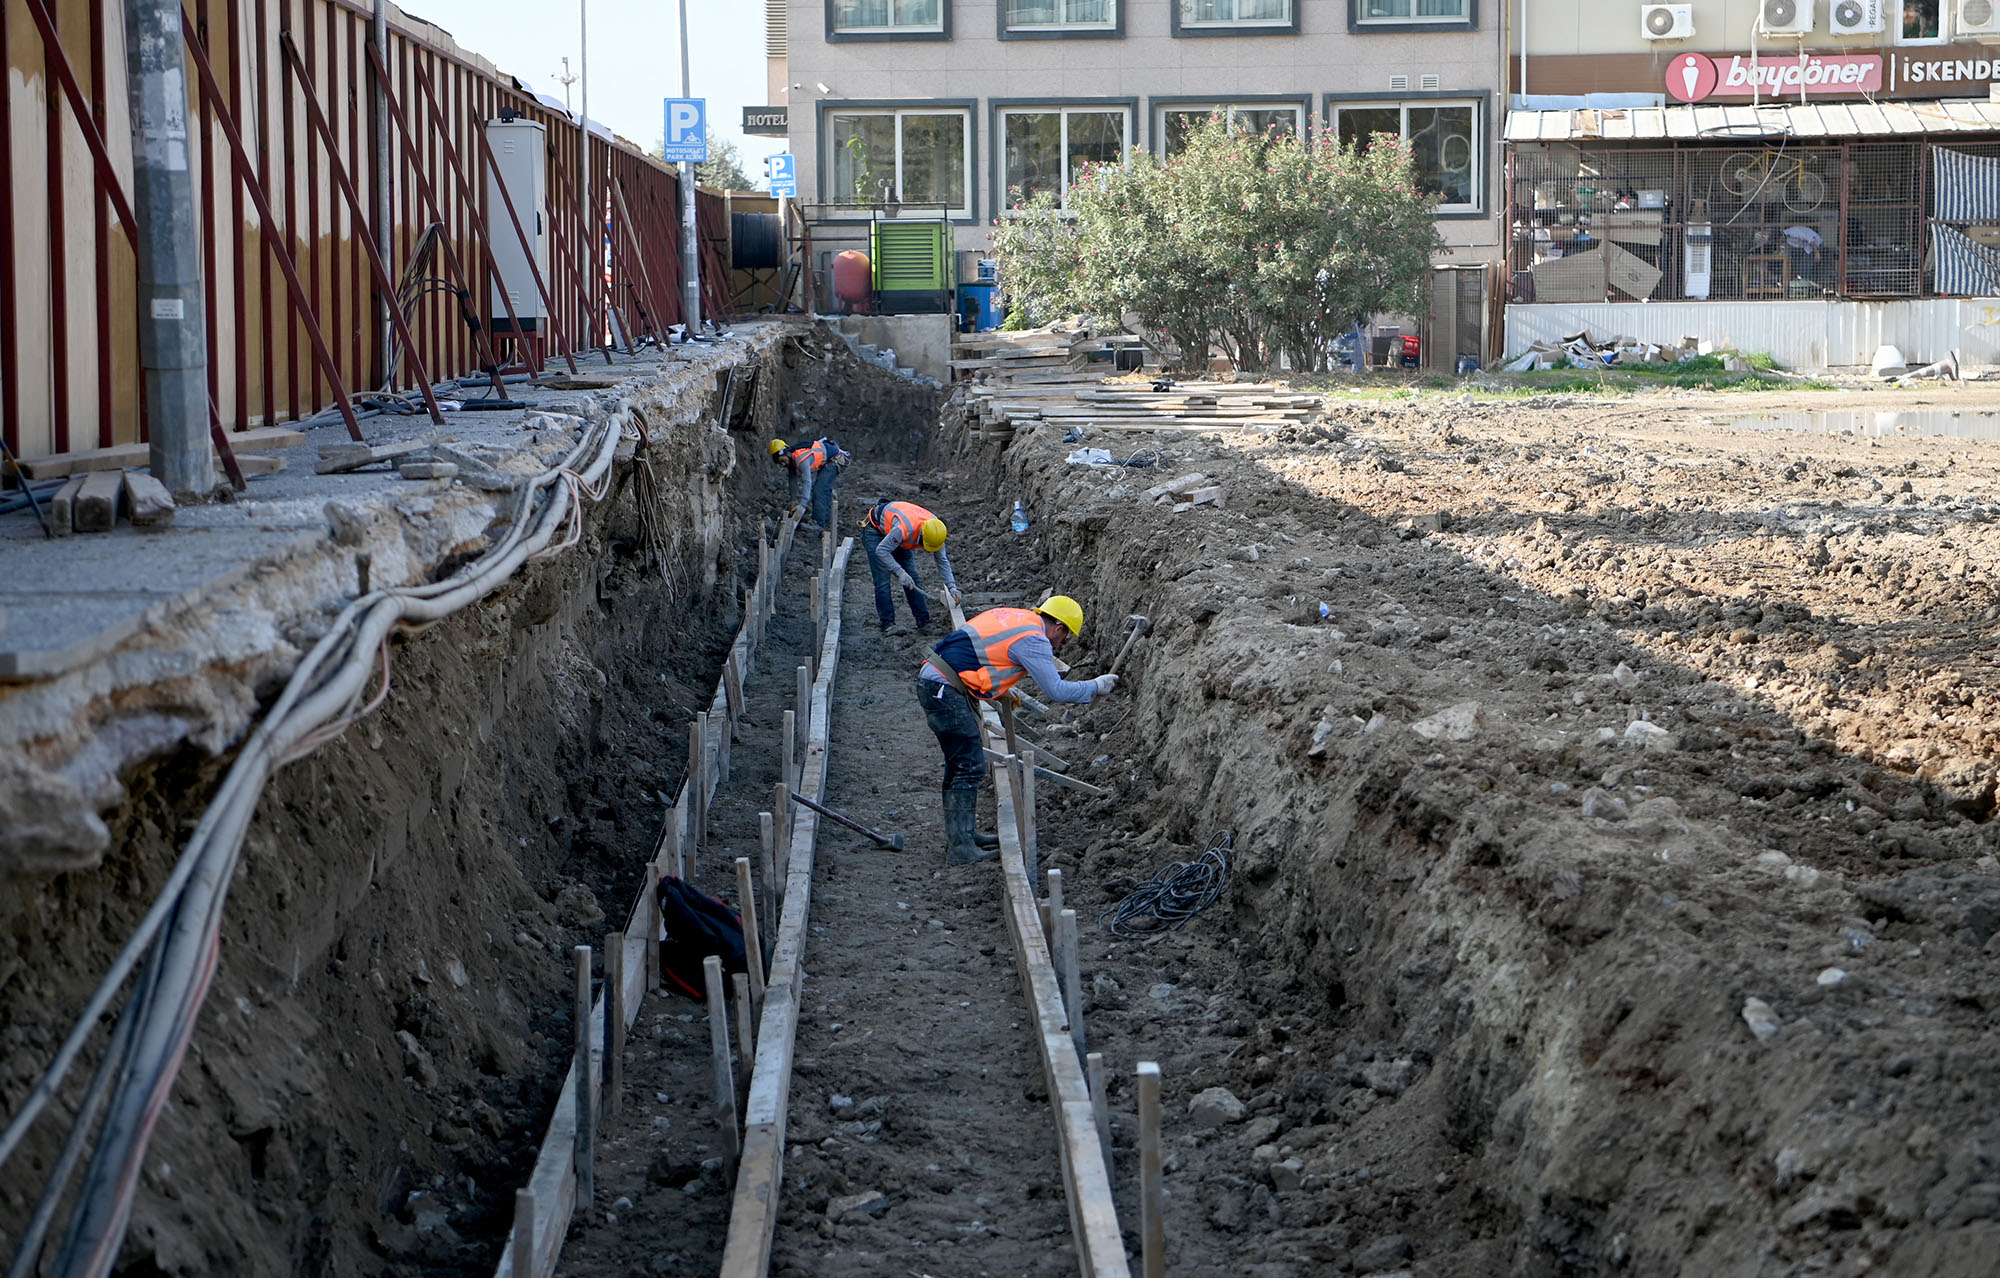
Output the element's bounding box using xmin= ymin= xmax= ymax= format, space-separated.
xmin=11 ymin=330 xmax=2000 ymax=1278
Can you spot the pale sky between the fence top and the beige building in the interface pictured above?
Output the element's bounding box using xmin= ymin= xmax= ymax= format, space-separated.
xmin=396 ymin=0 xmax=784 ymax=186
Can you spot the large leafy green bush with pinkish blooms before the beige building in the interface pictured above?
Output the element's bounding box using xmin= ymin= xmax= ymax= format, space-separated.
xmin=994 ymin=118 xmax=1442 ymax=370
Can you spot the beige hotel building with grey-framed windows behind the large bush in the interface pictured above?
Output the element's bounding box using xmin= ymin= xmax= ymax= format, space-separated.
xmin=766 ymin=0 xmax=1502 ymax=360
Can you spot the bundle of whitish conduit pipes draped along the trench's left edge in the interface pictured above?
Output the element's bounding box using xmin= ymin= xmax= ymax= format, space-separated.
xmin=0 ymin=422 xmax=622 ymax=1276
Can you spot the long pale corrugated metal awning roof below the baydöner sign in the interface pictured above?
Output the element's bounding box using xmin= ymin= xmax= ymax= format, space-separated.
xmin=1506 ymin=98 xmax=2000 ymax=142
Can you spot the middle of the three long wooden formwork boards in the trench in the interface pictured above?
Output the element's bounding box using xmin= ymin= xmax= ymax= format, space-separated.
xmin=720 ymin=538 xmax=854 ymax=1278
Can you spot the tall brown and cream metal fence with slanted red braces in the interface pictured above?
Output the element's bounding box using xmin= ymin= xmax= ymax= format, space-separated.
xmin=0 ymin=0 xmax=728 ymax=458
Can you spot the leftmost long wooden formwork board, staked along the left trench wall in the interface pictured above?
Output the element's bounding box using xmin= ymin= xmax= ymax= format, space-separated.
xmin=494 ymin=518 xmax=794 ymax=1278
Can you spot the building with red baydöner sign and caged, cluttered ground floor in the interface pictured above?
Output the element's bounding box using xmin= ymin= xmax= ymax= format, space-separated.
xmin=1502 ymin=0 xmax=2000 ymax=366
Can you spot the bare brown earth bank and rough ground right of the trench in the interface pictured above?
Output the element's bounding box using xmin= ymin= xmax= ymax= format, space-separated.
xmin=948 ymin=384 xmax=2000 ymax=1276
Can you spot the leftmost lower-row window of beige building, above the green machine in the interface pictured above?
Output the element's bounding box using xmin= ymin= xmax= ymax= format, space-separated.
xmin=826 ymin=106 xmax=972 ymax=218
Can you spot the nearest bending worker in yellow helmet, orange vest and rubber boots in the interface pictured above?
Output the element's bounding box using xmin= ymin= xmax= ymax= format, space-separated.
xmin=916 ymin=594 xmax=1118 ymax=866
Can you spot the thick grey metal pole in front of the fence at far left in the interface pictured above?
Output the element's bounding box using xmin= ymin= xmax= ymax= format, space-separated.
xmin=124 ymin=0 xmax=216 ymax=496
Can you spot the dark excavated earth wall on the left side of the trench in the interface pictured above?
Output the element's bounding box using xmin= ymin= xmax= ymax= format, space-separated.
xmin=0 ymin=328 xmax=936 ymax=1276
